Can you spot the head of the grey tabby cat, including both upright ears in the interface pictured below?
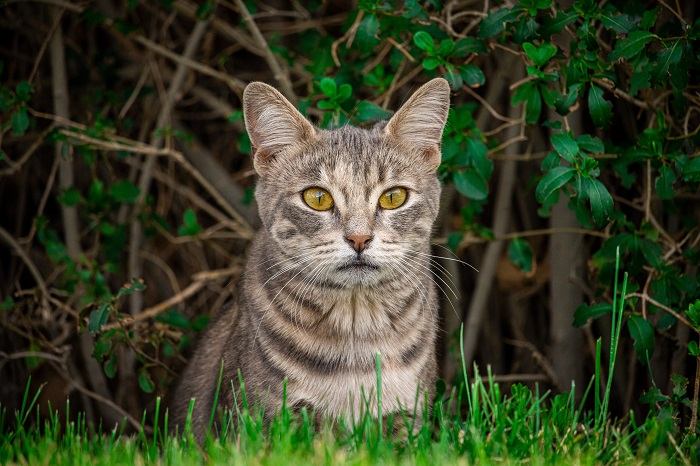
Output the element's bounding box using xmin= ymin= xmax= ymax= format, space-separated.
xmin=243 ymin=78 xmax=450 ymax=287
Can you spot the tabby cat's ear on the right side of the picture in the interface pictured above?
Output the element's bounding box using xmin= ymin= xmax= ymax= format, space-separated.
xmin=384 ymin=78 xmax=450 ymax=168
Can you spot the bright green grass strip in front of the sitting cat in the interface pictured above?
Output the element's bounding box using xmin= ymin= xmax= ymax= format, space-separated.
xmin=0 ymin=249 xmax=698 ymax=465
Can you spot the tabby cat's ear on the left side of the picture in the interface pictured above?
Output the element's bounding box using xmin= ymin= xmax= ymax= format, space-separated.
xmin=243 ymin=82 xmax=316 ymax=175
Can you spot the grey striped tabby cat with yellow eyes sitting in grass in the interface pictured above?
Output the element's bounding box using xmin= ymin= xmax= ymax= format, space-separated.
xmin=172 ymin=78 xmax=450 ymax=438
